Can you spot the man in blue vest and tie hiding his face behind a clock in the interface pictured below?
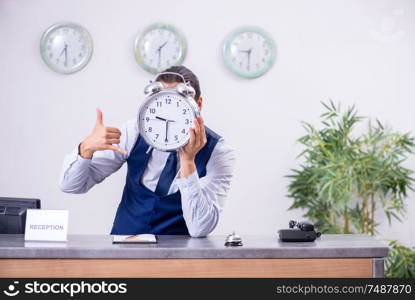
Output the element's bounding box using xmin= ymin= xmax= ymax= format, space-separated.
xmin=60 ymin=66 xmax=235 ymax=237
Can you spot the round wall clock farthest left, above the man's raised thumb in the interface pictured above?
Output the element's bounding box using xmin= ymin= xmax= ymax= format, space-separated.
xmin=40 ymin=23 xmax=93 ymax=74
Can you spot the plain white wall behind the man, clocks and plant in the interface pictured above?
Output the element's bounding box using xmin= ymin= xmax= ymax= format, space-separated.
xmin=0 ymin=0 xmax=415 ymax=244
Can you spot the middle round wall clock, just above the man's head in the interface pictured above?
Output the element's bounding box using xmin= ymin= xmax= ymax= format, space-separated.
xmin=134 ymin=23 xmax=187 ymax=74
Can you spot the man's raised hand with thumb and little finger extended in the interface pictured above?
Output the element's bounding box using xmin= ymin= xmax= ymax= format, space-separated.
xmin=79 ymin=109 xmax=127 ymax=159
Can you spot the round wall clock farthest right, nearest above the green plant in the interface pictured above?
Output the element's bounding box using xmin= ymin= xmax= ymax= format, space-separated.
xmin=223 ymin=27 xmax=275 ymax=78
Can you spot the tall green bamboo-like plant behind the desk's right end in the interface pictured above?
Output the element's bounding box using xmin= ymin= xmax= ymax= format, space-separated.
xmin=288 ymin=101 xmax=415 ymax=274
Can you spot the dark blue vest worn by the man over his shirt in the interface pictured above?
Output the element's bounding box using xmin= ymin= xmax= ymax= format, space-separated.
xmin=111 ymin=127 xmax=220 ymax=235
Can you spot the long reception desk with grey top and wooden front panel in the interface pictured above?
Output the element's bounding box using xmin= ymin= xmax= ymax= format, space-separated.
xmin=0 ymin=234 xmax=388 ymax=277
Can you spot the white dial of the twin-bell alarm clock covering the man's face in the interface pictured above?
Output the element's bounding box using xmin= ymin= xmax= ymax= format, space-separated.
xmin=138 ymin=90 xmax=198 ymax=151
